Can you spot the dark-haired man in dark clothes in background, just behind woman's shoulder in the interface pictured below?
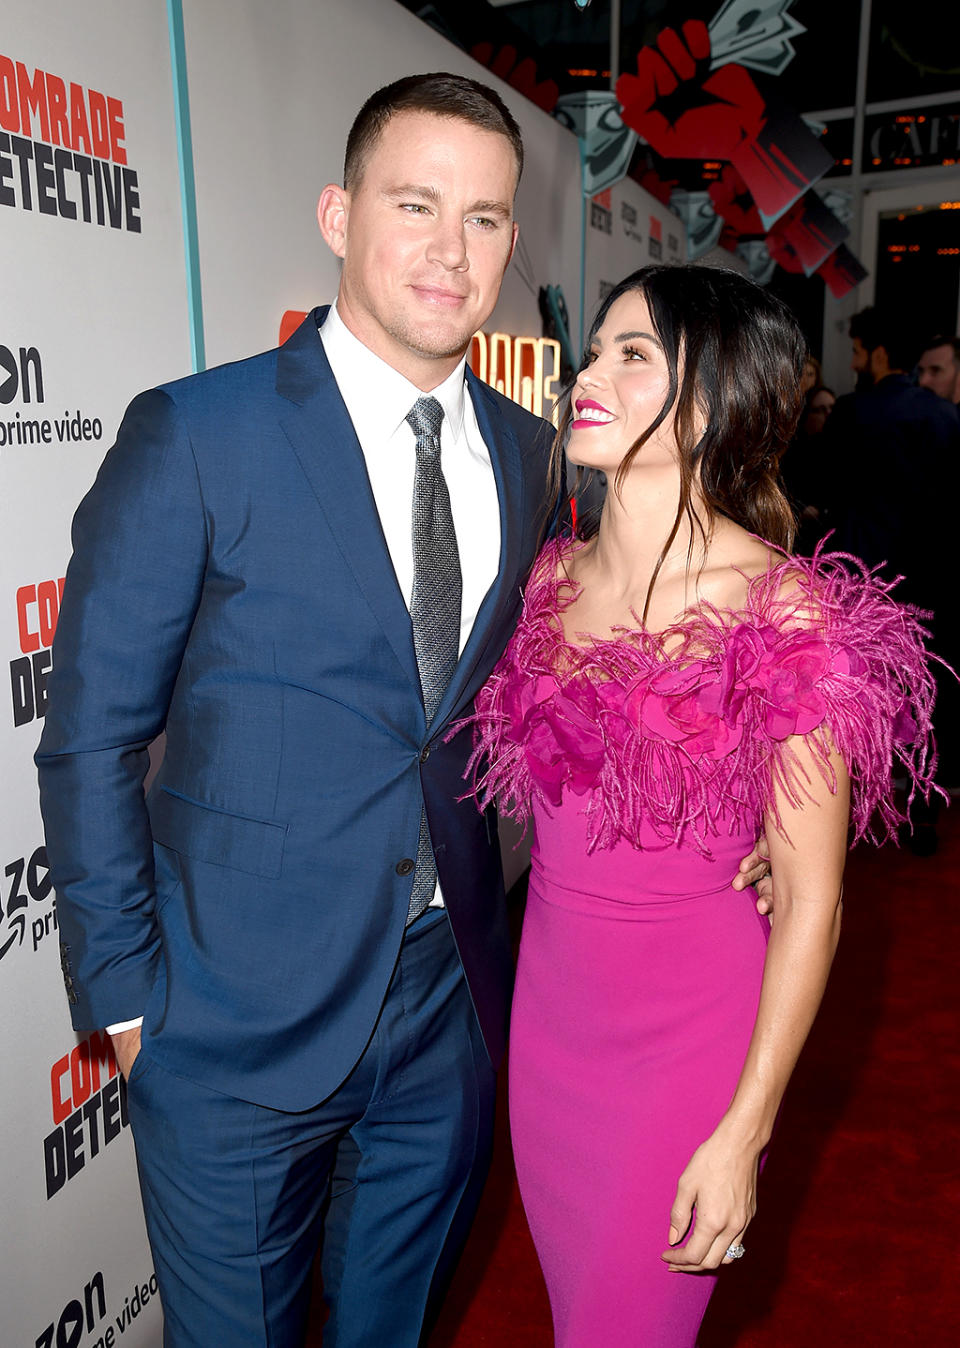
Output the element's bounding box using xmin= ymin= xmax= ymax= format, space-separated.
xmin=822 ymin=309 xmax=960 ymax=856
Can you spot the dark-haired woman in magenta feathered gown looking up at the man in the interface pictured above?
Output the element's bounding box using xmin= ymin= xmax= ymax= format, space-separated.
xmin=475 ymin=267 xmax=932 ymax=1348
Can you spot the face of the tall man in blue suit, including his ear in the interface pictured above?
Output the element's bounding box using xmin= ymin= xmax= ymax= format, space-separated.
xmin=318 ymin=112 xmax=516 ymax=391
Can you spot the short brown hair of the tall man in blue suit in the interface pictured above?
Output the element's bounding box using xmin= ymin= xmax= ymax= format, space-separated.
xmin=344 ymin=70 xmax=523 ymax=189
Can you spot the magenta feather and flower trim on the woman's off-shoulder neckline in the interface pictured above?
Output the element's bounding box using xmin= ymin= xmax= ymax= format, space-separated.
xmin=454 ymin=541 xmax=937 ymax=852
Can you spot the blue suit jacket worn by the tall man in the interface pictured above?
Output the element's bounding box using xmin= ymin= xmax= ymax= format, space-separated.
xmin=38 ymin=310 xmax=546 ymax=1109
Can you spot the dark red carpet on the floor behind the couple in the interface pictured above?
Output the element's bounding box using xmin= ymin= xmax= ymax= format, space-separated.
xmin=311 ymin=802 xmax=960 ymax=1348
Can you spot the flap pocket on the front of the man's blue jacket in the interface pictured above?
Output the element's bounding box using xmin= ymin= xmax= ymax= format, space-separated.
xmin=150 ymin=786 xmax=287 ymax=880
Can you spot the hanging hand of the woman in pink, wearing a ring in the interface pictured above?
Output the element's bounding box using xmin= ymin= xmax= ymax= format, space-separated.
xmin=661 ymin=1123 xmax=763 ymax=1273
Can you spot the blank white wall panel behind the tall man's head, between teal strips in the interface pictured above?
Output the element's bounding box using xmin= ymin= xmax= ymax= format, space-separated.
xmin=183 ymin=0 xmax=580 ymax=364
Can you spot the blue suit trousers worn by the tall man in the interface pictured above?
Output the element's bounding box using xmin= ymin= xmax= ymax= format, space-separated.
xmin=128 ymin=909 xmax=495 ymax=1348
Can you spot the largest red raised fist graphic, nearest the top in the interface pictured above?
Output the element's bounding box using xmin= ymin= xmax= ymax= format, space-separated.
xmin=616 ymin=19 xmax=766 ymax=159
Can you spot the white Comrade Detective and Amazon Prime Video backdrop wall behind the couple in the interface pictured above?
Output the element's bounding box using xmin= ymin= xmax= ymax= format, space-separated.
xmin=0 ymin=0 xmax=685 ymax=1348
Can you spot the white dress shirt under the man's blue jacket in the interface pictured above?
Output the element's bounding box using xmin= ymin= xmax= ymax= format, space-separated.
xmin=107 ymin=305 xmax=500 ymax=1034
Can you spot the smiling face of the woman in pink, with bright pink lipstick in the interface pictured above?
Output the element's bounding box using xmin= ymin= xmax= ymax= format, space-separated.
xmin=566 ymin=290 xmax=677 ymax=473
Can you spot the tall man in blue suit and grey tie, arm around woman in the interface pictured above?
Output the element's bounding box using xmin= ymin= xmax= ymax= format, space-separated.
xmin=38 ymin=74 xmax=771 ymax=1348
